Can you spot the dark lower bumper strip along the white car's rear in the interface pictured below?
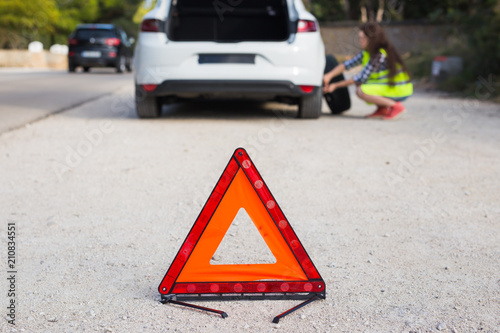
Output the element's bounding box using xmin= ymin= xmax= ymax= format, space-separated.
xmin=136 ymin=80 xmax=320 ymax=99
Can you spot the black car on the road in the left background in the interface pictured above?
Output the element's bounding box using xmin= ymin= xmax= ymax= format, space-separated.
xmin=68 ymin=24 xmax=134 ymax=73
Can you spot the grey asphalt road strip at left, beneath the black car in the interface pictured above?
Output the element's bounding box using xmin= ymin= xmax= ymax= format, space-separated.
xmin=0 ymin=68 xmax=133 ymax=133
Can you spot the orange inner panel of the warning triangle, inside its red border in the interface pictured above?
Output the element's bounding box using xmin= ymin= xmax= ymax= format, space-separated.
xmin=177 ymin=170 xmax=307 ymax=282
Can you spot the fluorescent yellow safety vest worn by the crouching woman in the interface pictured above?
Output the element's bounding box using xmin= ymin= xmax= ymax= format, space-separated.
xmin=361 ymin=49 xmax=413 ymax=99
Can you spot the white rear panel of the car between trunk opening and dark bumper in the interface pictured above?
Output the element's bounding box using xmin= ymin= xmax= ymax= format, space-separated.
xmin=134 ymin=33 xmax=325 ymax=86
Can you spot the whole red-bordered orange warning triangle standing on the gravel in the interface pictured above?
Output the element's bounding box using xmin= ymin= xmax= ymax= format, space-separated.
xmin=158 ymin=148 xmax=326 ymax=299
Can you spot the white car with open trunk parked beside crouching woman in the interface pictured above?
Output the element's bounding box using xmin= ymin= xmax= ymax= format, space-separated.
xmin=134 ymin=0 xmax=325 ymax=118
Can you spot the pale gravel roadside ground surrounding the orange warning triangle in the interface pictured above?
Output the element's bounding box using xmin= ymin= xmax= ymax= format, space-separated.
xmin=0 ymin=77 xmax=500 ymax=333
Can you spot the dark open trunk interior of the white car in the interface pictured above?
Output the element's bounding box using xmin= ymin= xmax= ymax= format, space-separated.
xmin=166 ymin=0 xmax=292 ymax=42
